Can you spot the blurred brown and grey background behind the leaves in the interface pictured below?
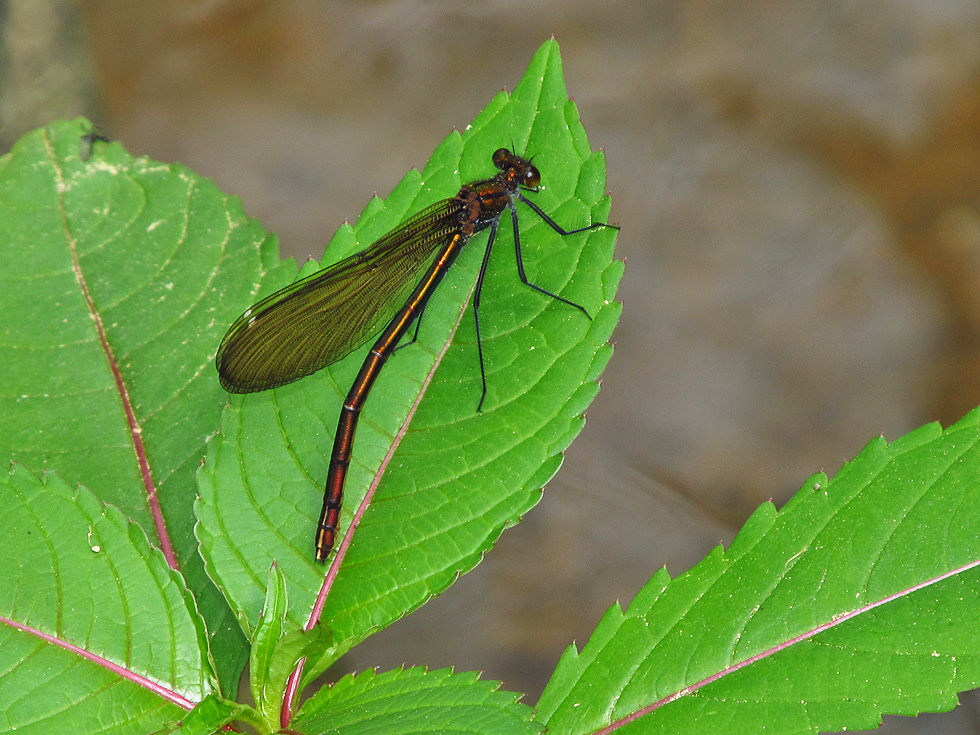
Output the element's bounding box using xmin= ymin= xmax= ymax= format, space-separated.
xmin=7 ymin=0 xmax=980 ymax=733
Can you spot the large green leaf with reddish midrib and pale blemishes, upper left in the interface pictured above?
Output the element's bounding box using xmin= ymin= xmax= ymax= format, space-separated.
xmin=0 ymin=120 xmax=272 ymax=691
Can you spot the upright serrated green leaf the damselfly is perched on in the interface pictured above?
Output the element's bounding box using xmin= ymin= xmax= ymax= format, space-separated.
xmin=197 ymin=36 xmax=622 ymax=673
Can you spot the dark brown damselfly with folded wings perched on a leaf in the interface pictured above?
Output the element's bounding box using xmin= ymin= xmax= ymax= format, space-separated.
xmin=215 ymin=148 xmax=618 ymax=562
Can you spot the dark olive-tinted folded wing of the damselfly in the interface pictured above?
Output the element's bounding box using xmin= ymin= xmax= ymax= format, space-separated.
xmin=215 ymin=199 xmax=461 ymax=393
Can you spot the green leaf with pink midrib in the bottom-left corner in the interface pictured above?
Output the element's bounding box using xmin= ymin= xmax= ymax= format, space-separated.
xmin=0 ymin=465 xmax=217 ymax=735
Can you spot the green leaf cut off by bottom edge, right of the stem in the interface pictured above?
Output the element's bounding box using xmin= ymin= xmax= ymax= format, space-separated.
xmin=290 ymin=668 xmax=542 ymax=735
